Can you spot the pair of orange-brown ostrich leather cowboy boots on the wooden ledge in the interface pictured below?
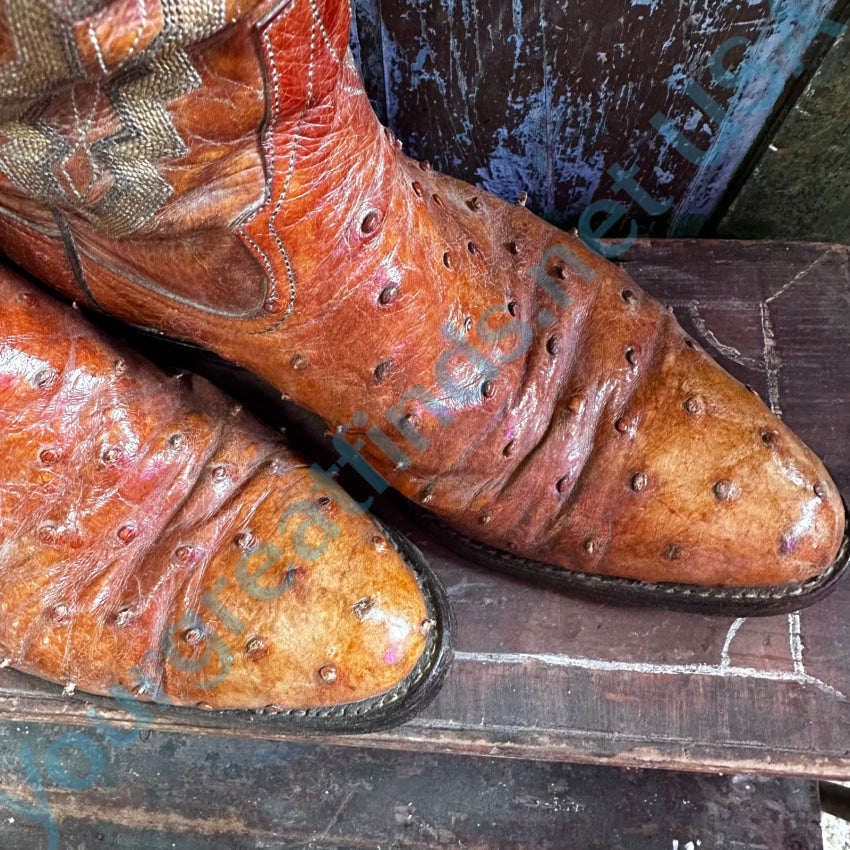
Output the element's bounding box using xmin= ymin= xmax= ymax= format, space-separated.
xmin=0 ymin=0 xmax=847 ymax=731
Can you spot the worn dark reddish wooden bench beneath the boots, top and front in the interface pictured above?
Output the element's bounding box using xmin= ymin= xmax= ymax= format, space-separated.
xmin=0 ymin=240 xmax=850 ymax=848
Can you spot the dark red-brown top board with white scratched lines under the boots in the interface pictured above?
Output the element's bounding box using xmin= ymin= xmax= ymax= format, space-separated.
xmin=0 ymin=240 xmax=850 ymax=778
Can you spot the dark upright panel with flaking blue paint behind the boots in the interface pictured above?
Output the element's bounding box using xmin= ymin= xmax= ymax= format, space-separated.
xmin=355 ymin=0 xmax=831 ymax=235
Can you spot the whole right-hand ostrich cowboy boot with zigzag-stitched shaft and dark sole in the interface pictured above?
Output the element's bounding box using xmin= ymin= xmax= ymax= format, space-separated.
xmin=0 ymin=0 xmax=846 ymax=612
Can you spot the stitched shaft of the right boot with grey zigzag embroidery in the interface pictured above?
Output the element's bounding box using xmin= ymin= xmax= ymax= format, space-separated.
xmin=0 ymin=0 xmax=362 ymax=318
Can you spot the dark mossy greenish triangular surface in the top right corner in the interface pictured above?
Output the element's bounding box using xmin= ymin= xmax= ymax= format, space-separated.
xmin=717 ymin=32 xmax=850 ymax=243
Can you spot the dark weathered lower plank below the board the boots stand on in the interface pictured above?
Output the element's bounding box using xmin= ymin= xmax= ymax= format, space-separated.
xmin=0 ymin=723 xmax=822 ymax=850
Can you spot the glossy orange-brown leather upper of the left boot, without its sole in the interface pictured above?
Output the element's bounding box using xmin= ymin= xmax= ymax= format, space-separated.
xmin=0 ymin=270 xmax=428 ymax=709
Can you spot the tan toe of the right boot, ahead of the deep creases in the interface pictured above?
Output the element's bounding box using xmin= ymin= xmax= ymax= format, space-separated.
xmin=572 ymin=336 xmax=845 ymax=586
